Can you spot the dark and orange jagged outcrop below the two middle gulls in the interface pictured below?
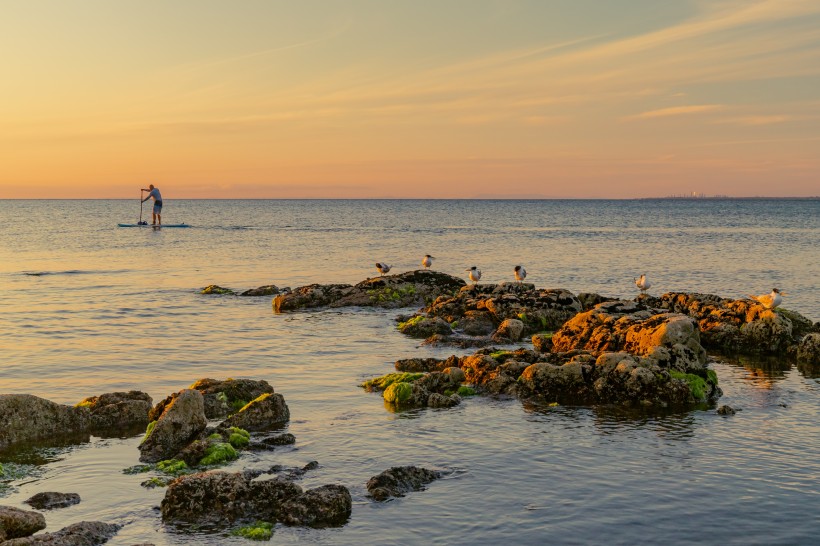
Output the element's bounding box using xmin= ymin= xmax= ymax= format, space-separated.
xmin=399 ymin=283 xmax=582 ymax=347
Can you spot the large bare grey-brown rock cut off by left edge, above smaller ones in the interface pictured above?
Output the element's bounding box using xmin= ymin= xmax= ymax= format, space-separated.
xmin=0 ymin=394 xmax=91 ymax=449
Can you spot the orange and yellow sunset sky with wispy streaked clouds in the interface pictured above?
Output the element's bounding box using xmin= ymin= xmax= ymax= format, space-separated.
xmin=0 ymin=0 xmax=820 ymax=199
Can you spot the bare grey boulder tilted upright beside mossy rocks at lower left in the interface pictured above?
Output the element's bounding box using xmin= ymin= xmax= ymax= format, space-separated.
xmin=139 ymin=389 xmax=208 ymax=463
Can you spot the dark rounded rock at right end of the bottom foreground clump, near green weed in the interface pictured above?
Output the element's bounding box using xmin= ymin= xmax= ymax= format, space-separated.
xmin=279 ymin=485 xmax=353 ymax=527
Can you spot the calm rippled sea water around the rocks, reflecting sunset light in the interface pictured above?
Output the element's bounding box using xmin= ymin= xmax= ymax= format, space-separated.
xmin=0 ymin=200 xmax=820 ymax=546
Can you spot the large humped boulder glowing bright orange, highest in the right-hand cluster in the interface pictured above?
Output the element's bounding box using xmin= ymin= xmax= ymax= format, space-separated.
xmin=552 ymin=301 xmax=706 ymax=373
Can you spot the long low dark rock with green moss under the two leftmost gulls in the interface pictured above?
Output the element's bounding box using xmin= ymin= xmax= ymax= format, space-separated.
xmin=273 ymin=269 xmax=464 ymax=313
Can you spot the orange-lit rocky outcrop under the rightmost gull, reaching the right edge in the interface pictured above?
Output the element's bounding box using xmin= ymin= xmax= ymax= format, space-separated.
xmin=638 ymin=292 xmax=813 ymax=354
